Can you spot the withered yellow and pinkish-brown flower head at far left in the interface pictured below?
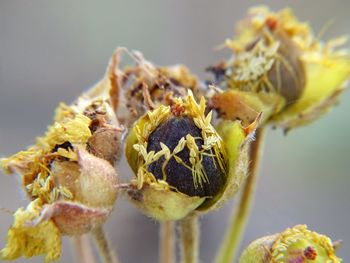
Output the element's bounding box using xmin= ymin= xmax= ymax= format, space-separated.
xmin=0 ymin=54 xmax=121 ymax=262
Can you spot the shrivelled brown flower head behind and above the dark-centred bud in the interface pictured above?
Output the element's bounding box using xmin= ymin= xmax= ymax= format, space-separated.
xmin=109 ymin=48 xmax=201 ymax=127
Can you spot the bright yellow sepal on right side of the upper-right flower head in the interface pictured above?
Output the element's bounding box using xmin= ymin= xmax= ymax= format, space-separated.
xmin=271 ymin=55 xmax=350 ymax=131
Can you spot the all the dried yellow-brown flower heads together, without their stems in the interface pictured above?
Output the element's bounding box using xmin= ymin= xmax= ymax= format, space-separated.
xmin=0 ymin=5 xmax=350 ymax=263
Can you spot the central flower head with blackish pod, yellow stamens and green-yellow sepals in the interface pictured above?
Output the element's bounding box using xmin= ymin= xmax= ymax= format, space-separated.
xmin=126 ymin=92 xmax=258 ymax=220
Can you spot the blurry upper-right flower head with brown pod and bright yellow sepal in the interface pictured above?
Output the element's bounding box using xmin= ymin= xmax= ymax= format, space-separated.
xmin=210 ymin=7 xmax=350 ymax=131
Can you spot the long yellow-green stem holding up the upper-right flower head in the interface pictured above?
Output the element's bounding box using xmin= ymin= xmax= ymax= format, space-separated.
xmin=215 ymin=127 xmax=265 ymax=263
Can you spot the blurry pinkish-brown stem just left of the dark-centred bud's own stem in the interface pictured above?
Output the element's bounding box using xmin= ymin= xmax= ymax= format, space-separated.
xmin=159 ymin=221 xmax=175 ymax=263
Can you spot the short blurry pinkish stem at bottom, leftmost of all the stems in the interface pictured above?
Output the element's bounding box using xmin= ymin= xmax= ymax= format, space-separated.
xmin=72 ymin=235 xmax=96 ymax=263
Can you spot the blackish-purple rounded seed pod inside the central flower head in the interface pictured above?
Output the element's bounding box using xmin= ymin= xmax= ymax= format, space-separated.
xmin=147 ymin=116 xmax=226 ymax=197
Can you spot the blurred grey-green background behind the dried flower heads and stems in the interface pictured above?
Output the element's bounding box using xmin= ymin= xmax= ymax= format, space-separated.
xmin=0 ymin=0 xmax=350 ymax=263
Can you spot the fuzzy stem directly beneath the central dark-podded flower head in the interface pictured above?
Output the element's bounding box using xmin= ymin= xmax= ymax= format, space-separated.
xmin=180 ymin=213 xmax=200 ymax=263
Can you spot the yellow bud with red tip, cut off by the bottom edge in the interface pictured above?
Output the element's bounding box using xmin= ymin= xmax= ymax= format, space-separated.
xmin=239 ymin=225 xmax=342 ymax=263
